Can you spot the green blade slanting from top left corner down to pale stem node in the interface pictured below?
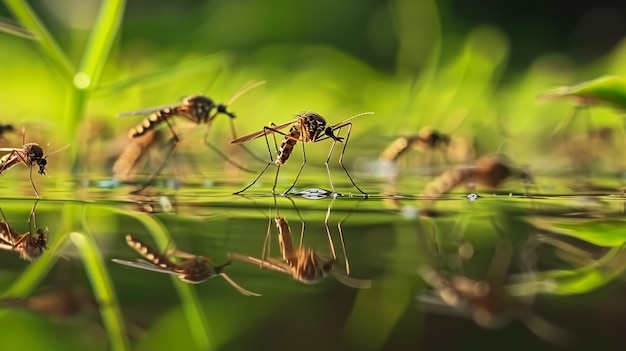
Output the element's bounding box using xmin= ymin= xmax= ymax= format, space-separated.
xmin=4 ymin=0 xmax=74 ymax=80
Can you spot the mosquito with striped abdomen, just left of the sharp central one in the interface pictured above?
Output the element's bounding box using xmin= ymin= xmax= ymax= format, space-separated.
xmin=118 ymin=81 xmax=265 ymax=193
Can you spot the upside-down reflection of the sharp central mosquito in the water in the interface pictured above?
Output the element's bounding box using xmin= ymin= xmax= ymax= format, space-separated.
xmin=228 ymin=198 xmax=372 ymax=289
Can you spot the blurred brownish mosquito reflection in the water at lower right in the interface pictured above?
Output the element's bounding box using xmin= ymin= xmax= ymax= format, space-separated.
xmin=418 ymin=218 xmax=571 ymax=344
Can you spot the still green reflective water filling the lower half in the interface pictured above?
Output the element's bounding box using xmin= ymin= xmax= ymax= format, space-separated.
xmin=0 ymin=170 xmax=626 ymax=350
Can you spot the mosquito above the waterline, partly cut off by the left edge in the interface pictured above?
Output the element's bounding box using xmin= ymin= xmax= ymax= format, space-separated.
xmin=0 ymin=129 xmax=69 ymax=199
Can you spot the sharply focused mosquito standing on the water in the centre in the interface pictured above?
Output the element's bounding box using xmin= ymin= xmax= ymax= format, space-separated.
xmin=230 ymin=111 xmax=374 ymax=197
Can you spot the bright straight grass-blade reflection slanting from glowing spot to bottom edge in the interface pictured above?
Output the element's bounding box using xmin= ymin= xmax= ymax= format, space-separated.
xmin=70 ymin=232 xmax=129 ymax=350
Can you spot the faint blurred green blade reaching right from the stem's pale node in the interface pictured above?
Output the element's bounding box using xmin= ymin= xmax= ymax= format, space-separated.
xmin=94 ymin=53 xmax=227 ymax=95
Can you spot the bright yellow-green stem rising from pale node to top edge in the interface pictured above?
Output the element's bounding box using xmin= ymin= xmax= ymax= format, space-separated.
xmin=74 ymin=0 xmax=126 ymax=89
